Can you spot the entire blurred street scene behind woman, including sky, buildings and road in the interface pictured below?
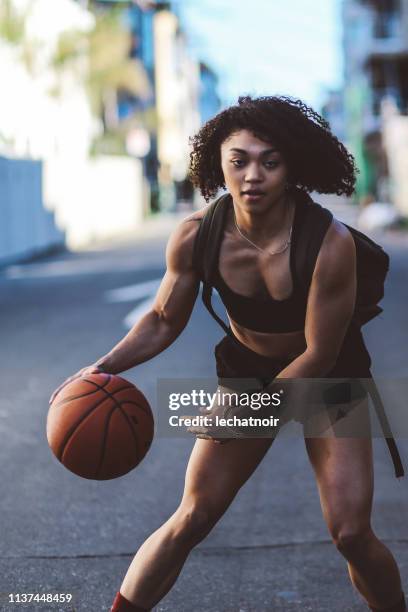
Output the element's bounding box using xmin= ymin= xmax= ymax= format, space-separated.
xmin=0 ymin=0 xmax=408 ymax=612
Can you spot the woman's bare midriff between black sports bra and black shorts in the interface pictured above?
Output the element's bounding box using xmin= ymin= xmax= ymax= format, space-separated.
xmin=228 ymin=317 xmax=306 ymax=360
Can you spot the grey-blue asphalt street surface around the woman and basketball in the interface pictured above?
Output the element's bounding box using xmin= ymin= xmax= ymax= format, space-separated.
xmin=0 ymin=208 xmax=408 ymax=612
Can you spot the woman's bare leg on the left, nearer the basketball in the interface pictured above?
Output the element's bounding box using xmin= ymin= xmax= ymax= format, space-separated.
xmin=120 ymin=439 xmax=272 ymax=610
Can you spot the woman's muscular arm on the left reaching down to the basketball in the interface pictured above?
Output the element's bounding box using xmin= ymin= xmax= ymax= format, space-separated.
xmin=50 ymin=215 xmax=200 ymax=402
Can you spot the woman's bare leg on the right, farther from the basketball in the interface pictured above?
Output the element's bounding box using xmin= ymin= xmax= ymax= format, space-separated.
xmin=305 ymin=404 xmax=403 ymax=609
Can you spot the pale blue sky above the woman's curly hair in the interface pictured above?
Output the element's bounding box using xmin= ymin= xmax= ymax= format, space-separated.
xmin=175 ymin=0 xmax=343 ymax=110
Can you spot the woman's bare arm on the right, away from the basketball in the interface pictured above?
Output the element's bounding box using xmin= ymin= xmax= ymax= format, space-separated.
xmin=277 ymin=220 xmax=357 ymax=378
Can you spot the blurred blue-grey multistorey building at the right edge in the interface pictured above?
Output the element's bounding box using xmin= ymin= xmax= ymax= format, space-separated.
xmin=343 ymin=0 xmax=408 ymax=212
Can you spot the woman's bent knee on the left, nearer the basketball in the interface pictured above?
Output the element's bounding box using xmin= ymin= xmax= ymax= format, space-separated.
xmin=172 ymin=499 xmax=223 ymax=546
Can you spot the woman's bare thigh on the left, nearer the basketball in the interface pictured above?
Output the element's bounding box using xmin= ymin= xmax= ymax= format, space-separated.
xmin=183 ymin=438 xmax=272 ymax=512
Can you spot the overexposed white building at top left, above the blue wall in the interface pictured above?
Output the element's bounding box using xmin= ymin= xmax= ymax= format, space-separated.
xmin=0 ymin=0 xmax=96 ymax=159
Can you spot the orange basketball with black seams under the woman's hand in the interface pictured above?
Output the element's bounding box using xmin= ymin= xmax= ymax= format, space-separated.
xmin=47 ymin=372 xmax=154 ymax=480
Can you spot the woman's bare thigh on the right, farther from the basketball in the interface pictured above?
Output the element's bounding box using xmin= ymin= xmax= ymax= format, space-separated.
xmin=305 ymin=405 xmax=373 ymax=524
